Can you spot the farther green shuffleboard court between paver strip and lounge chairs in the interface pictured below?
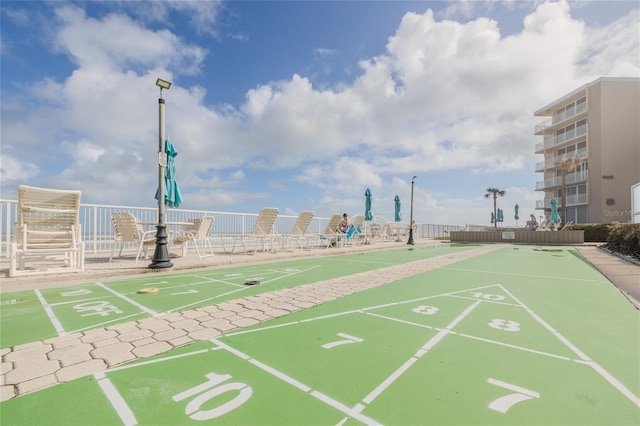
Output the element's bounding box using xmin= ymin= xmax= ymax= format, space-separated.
xmin=0 ymin=244 xmax=474 ymax=348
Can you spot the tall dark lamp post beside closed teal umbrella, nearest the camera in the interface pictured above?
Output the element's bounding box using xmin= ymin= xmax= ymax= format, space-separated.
xmin=149 ymin=78 xmax=173 ymax=269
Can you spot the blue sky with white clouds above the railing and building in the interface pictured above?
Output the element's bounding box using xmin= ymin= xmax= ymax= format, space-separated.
xmin=0 ymin=0 xmax=640 ymax=226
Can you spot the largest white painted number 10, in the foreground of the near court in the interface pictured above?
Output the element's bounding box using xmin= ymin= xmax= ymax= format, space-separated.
xmin=173 ymin=373 xmax=253 ymax=420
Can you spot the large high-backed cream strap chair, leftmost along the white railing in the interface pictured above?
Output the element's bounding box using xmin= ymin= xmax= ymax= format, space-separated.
xmin=9 ymin=185 xmax=84 ymax=277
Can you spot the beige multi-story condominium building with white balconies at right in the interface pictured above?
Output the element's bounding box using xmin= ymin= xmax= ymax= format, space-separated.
xmin=534 ymin=77 xmax=640 ymax=223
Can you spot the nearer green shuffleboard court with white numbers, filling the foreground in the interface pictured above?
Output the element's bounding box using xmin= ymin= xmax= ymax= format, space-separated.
xmin=0 ymin=246 xmax=640 ymax=425
